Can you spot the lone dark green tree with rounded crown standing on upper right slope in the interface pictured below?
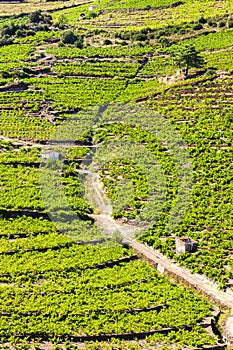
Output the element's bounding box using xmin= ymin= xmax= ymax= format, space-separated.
xmin=173 ymin=45 xmax=205 ymax=78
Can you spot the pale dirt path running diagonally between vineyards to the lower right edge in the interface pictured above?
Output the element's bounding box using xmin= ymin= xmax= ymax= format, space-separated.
xmin=87 ymin=173 xmax=233 ymax=344
